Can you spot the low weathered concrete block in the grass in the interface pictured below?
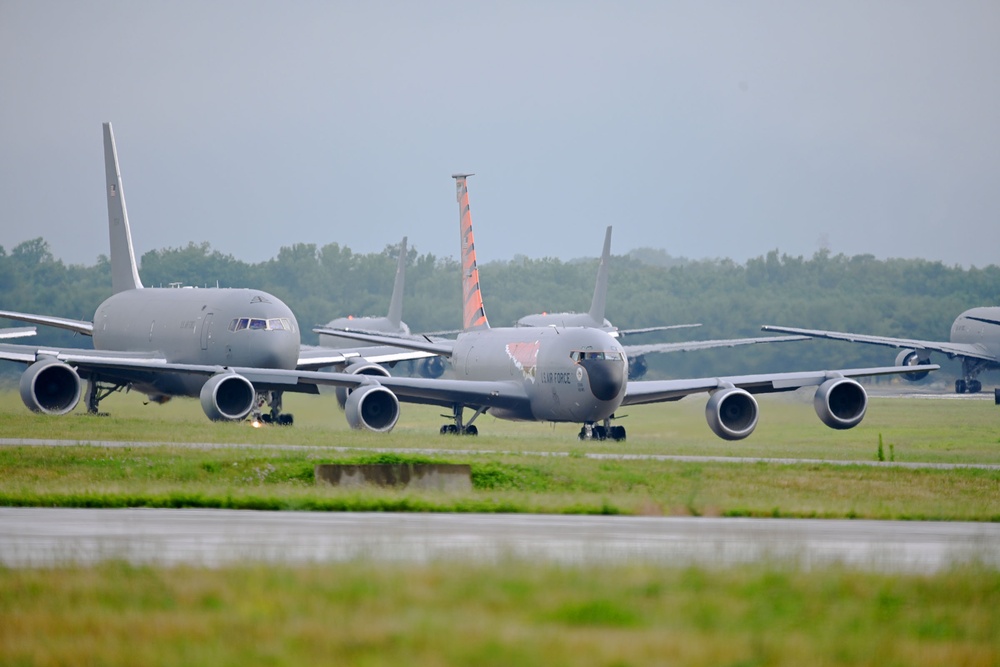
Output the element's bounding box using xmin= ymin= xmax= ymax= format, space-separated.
xmin=314 ymin=463 xmax=472 ymax=491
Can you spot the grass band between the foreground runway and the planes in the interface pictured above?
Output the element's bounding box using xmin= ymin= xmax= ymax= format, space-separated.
xmin=0 ymin=396 xmax=1000 ymax=521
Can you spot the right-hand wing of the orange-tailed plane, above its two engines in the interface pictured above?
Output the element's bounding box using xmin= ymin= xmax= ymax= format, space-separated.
xmin=622 ymin=364 xmax=941 ymax=405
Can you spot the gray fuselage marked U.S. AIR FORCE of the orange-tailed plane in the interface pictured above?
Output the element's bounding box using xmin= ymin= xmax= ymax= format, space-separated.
xmin=451 ymin=327 xmax=628 ymax=423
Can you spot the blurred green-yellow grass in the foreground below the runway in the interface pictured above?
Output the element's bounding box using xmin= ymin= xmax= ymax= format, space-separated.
xmin=0 ymin=562 xmax=1000 ymax=667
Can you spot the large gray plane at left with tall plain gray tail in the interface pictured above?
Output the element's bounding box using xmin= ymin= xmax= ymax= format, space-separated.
xmin=0 ymin=123 xmax=422 ymax=423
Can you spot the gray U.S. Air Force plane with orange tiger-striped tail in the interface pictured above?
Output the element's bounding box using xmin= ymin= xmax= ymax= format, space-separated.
xmin=312 ymin=174 xmax=936 ymax=440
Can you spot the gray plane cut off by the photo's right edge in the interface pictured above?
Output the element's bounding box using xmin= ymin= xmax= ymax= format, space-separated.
xmin=761 ymin=306 xmax=1000 ymax=394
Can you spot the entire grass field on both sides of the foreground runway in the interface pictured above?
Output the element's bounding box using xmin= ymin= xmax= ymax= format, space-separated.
xmin=0 ymin=394 xmax=1000 ymax=667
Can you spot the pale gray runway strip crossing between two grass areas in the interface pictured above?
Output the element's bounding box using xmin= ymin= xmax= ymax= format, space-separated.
xmin=0 ymin=507 xmax=1000 ymax=572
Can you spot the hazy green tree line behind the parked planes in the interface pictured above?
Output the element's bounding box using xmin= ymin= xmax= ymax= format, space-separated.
xmin=0 ymin=238 xmax=1000 ymax=380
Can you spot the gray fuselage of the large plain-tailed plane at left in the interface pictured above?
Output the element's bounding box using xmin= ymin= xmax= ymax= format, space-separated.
xmin=93 ymin=288 xmax=299 ymax=396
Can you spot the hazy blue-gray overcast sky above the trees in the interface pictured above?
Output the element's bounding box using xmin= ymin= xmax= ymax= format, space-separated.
xmin=0 ymin=0 xmax=1000 ymax=267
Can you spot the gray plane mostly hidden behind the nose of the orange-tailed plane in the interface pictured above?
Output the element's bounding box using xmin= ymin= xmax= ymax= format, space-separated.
xmin=512 ymin=226 xmax=808 ymax=380
